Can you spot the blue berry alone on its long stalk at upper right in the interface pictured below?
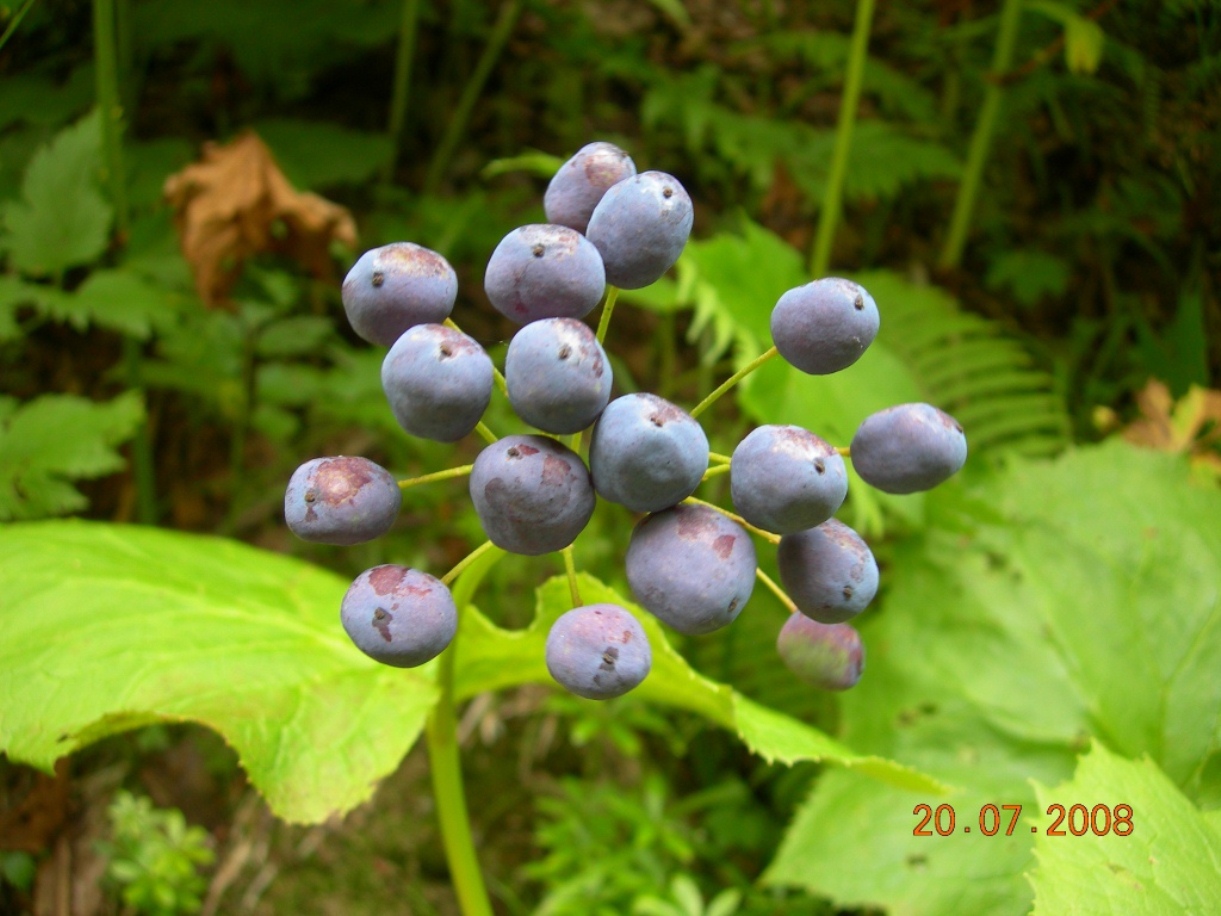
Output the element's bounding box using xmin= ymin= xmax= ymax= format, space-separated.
xmin=772 ymin=277 xmax=878 ymax=375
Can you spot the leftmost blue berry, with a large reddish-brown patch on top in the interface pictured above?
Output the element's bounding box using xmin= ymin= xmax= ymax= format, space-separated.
xmin=284 ymin=456 xmax=403 ymax=546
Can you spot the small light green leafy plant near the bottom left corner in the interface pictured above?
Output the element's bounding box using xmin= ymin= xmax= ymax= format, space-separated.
xmin=100 ymin=791 xmax=215 ymax=916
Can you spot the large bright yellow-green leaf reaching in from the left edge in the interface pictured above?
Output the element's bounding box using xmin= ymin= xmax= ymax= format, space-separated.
xmin=0 ymin=522 xmax=436 ymax=822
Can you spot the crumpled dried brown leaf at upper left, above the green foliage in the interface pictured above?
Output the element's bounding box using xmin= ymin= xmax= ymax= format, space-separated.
xmin=164 ymin=131 xmax=357 ymax=308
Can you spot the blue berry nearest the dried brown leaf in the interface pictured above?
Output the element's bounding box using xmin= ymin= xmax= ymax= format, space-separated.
xmin=343 ymin=242 xmax=458 ymax=347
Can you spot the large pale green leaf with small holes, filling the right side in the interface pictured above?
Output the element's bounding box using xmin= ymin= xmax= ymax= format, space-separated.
xmin=769 ymin=442 xmax=1221 ymax=914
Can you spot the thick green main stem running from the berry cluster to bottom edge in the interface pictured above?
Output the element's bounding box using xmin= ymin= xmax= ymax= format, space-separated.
xmin=425 ymin=542 xmax=504 ymax=916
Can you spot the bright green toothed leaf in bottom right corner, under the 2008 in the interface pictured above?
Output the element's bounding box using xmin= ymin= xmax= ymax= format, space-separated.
xmin=1031 ymin=744 xmax=1221 ymax=916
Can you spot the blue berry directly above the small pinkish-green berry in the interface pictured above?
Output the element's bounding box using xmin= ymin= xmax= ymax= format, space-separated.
xmin=777 ymin=519 xmax=878 ymax=623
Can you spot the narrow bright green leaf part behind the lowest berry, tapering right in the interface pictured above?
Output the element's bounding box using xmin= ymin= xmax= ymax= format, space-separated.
xmin=455 ymin=575 xmax=944 ymax=794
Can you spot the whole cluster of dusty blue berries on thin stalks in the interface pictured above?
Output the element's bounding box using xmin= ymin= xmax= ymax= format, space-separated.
xmin=284 ymin=143 xmax=967 ymax=699
